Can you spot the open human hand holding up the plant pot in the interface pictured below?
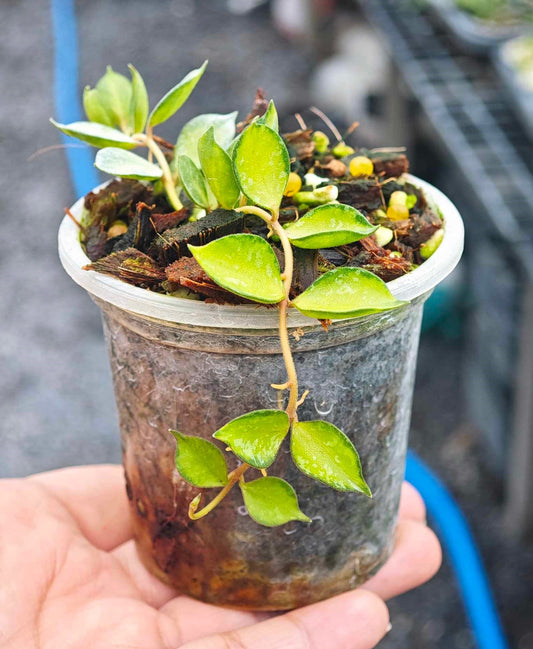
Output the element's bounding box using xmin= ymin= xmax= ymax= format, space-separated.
xmin=0 ymin=466 xmax=441 ymax=649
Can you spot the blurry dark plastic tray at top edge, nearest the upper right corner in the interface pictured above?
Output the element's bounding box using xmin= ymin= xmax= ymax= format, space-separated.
xmin=429 ymin=0 xmax=526 ymax=54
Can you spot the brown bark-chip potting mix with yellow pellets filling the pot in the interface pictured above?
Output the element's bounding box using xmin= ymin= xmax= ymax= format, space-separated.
xmin=78 ymin=142 xmax=436 ymax=304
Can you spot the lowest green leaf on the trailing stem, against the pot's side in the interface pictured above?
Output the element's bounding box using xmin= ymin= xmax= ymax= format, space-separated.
xmin=240 ymin=477 xmax=311 ymax=527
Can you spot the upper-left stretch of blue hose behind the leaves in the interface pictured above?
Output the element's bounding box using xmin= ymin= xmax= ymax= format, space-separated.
xmin=51 ymin=0 xmax=99 ymax=197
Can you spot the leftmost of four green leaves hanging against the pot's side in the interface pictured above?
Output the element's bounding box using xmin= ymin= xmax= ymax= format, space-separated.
xmin=170 ymin=430 xmax=228 ymax=488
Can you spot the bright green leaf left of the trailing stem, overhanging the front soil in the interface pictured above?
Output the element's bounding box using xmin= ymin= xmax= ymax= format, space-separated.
xmin=188 ymin=234 xmax=285 ymax=304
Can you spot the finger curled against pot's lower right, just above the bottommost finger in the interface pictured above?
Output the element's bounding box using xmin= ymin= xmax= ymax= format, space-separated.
xmin=363 ymin=520 xmax=442 ymax=600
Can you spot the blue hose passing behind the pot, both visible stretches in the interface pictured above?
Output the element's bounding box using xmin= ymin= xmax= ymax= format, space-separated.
xmin=51 ymin=0 xmax=508 ymax=649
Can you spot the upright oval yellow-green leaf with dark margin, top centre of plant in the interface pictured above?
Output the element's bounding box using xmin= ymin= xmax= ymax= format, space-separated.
xmin=233 ymin=122 xmax=290 ymax=210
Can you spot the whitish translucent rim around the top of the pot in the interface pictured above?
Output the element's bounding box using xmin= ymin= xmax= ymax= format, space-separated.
xmin=58 ymin=174 xmax=464 ymax=329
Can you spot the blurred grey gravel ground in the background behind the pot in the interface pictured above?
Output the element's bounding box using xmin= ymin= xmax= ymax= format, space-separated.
xmin=0 ymin=0 xmax=533 ymax=649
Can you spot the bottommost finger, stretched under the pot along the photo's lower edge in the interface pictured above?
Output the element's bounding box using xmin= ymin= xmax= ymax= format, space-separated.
xmin=181 ymin=589 xmax=389 ymax=649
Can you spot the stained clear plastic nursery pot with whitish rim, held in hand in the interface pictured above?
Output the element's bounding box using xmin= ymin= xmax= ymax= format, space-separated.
xmin=59 ymin=178 xmax=463 ymax=610
